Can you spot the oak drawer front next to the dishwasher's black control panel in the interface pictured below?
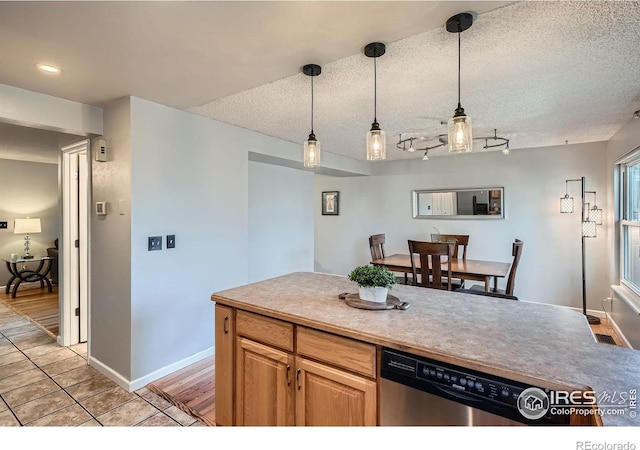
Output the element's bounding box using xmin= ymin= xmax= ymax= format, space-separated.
xmin=297 ymin=327 xmax=376 ymax=378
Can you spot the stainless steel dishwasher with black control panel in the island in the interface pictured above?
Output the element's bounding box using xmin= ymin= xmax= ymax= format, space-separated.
xmin=380 ymin=348 xmax=569 ymax=426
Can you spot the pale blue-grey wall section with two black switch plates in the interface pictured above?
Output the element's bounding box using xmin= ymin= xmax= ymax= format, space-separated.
xmin=131 ymin=98 xmax=254 ymax=380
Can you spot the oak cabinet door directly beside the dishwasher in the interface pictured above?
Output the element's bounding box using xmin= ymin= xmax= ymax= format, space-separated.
xmin=296 ymin=358 xmax=377 ymax=426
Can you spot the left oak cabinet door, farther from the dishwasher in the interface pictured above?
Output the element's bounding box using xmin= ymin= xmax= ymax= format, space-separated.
xmin=236 ymin=337 xmax=294 ymax=426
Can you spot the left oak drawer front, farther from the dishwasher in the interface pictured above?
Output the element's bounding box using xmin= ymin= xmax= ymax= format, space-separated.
xmin=236 ymin=311 xmax=293 ymax=352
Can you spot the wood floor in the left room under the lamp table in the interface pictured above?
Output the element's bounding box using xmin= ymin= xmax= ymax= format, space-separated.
xmin=0 ymin=285 xmax=60 ymax=338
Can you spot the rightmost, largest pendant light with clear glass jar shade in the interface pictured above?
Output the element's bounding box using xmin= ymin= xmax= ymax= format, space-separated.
xmin=447 ymin=13 xmax=473 ymax=153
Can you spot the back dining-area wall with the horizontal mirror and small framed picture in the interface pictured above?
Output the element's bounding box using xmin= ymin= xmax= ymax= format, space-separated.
xmin=315 ymin=143 xmax=611 ymax=311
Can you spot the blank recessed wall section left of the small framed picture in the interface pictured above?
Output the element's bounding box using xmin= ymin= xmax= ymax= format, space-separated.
xmin=249 ymin=161 xmax=314 ymax=282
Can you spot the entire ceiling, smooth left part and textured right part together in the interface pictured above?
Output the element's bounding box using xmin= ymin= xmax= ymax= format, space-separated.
xmin=0 ymin=1 xmax=640 ymax=160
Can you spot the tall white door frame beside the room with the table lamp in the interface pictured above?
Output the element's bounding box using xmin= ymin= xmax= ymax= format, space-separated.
xmin=58 ymin=139 xmax=92 ymax=353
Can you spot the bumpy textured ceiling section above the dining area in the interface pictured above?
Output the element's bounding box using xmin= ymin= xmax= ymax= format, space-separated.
xmin=190 ymin=2 xmax=640 ymax=159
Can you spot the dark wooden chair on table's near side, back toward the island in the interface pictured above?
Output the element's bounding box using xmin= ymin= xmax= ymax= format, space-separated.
xmin=408 ymin=240 xmax=454 ymax=291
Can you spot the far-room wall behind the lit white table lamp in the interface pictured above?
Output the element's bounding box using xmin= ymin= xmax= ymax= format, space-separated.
xmin=0 ymin=159 xmax=60 ymax=286
